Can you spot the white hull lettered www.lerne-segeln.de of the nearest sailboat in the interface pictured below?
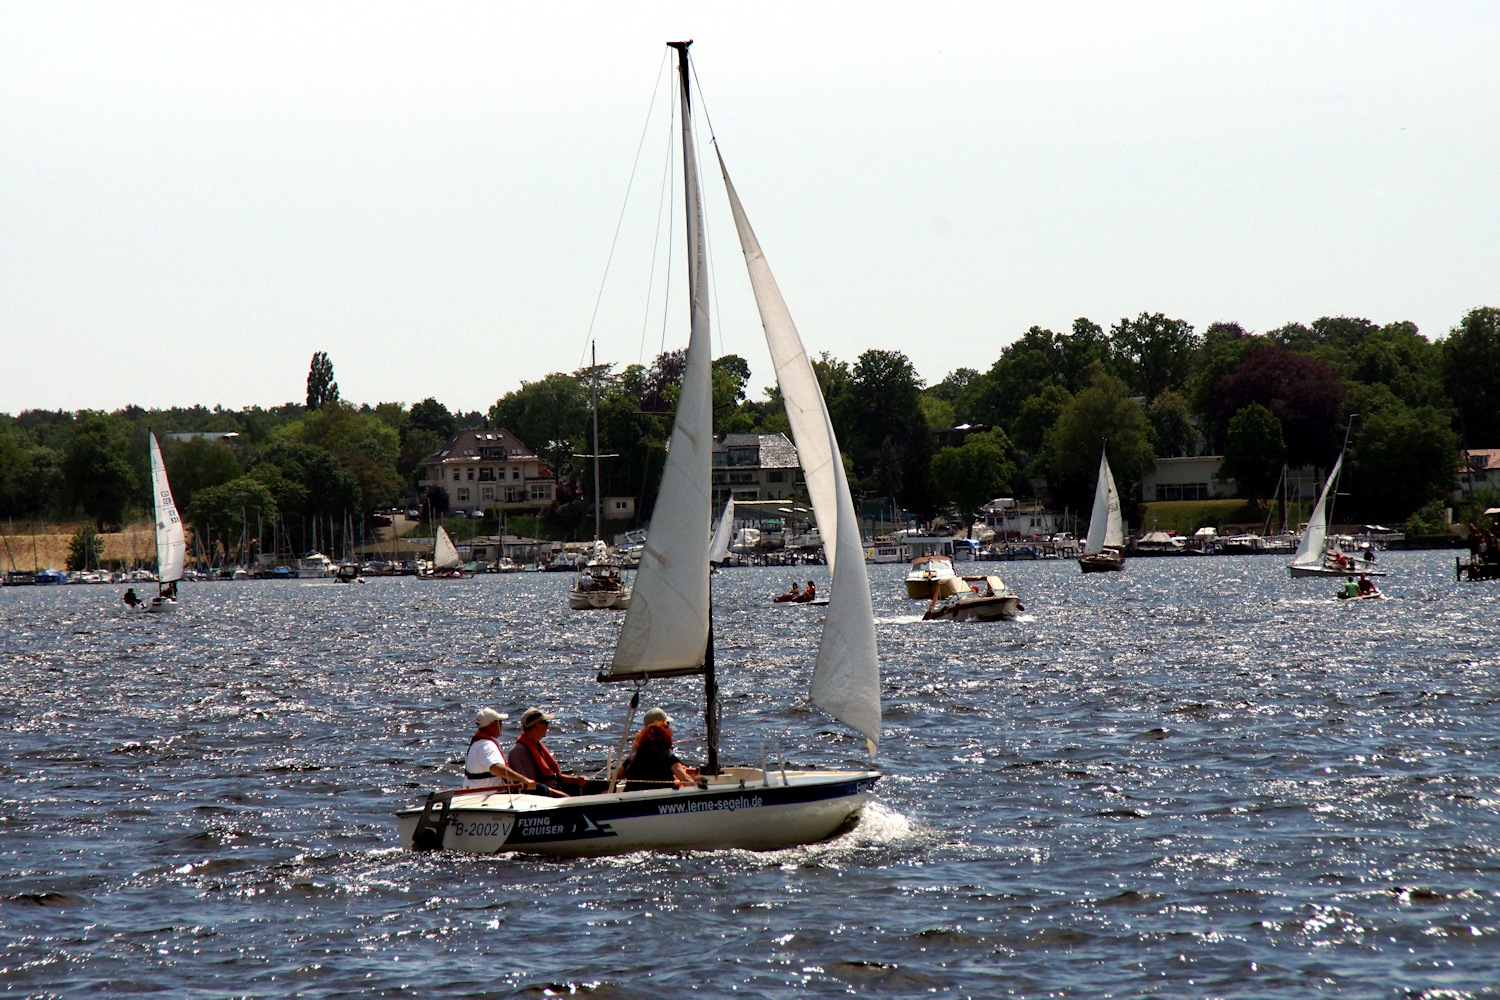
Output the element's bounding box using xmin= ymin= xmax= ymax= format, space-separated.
xmin=396 ymin=768 xmax=881 ymax=858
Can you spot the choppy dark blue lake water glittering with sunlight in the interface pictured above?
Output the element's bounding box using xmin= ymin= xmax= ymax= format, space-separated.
xmin=0 ymin=552 xmax=1500 ymax=997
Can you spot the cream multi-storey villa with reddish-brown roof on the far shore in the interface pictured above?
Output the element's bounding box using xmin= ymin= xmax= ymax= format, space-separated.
xmin=417 ymin=429 xmax=558 ymax=514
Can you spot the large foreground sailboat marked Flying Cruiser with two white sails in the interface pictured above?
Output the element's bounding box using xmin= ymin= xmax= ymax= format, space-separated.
xmin=398 ymin=42 xmax=881 ymax=856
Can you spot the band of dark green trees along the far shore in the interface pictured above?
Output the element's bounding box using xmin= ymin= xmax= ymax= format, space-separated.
xmin=0 ymin=307 xmax=1500 ymax=554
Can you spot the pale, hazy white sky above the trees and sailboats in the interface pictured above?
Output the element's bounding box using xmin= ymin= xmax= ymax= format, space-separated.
xmin=0 ymin=0 xmax=1500 ymax=414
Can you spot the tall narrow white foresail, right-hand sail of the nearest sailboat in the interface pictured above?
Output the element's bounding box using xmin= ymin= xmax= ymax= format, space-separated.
xmin=719 ymin=154 xmax=881 ymax=754
